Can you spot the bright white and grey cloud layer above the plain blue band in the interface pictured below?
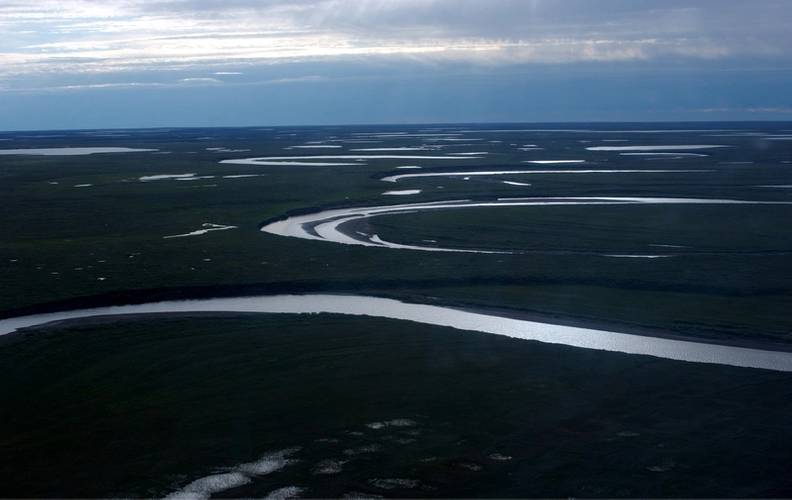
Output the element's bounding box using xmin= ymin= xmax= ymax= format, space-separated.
xmin=0 ymin=0 xmax=792 ymax=91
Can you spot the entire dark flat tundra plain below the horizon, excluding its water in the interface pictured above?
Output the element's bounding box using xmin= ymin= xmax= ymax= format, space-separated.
xmin=0 ymin=123 xmax=792 ymax=498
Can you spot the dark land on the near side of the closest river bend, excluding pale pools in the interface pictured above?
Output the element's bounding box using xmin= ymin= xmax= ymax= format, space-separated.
xmin=0 ymin=315 xmax=792 ymax=497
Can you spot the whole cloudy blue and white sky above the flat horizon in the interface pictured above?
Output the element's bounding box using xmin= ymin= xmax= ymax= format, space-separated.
xmin=0 ymin=0 xmax=792 ymax=130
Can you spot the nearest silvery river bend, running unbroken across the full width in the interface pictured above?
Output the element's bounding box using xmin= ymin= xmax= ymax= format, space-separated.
xmin=0 ymin=294 xmax=792 ymax=372
